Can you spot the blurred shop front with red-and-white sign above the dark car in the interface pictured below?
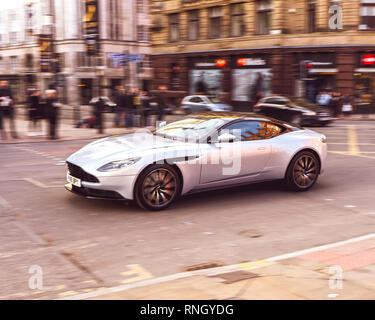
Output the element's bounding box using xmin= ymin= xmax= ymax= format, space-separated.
xmin=231 ymin=55 xmax=272 ymax=111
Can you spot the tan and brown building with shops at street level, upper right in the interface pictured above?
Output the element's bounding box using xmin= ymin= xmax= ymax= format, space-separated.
xmin=151 ymin=0 xmax=375 ymax=109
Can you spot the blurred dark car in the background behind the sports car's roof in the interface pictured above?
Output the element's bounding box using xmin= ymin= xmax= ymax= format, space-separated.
xmin=254 ymin=96 xmax=334 ymax=126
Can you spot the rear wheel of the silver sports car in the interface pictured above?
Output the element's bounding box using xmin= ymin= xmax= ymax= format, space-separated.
xmin=285 ymin=151 xmax=320 ymax=191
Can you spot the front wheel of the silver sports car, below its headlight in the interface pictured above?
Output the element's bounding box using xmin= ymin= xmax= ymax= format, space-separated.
xmin=135 ymin=165 xmax=181 ymax=211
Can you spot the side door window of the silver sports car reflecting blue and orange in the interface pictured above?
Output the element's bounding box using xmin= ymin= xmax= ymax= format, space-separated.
xmin=221 ymin=121 xmax=267 ymax=141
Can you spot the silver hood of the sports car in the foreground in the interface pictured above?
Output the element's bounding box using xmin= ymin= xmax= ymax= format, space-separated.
xmin=67 ymin=133 xmax=197 ymax=168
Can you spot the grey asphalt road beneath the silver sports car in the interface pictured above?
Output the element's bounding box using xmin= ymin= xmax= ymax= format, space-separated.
xmin=0 ymin=121 xmax=375 ymax=299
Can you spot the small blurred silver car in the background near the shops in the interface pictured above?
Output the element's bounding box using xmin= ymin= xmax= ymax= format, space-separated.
xmin=181 ymin=95 xmax=232 ymax=114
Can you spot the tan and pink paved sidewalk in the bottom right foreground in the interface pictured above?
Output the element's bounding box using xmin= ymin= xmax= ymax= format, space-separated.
xmin=64 ymin=234 xmax=375 ymax=300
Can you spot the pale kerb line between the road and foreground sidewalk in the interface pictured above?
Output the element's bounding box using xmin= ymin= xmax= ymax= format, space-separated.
xmin=57 ymin=233 xmax=375 ymax=300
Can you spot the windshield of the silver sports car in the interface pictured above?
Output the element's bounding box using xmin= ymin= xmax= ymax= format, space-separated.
xmin=155 ymin=117 xmax=225 ymax=142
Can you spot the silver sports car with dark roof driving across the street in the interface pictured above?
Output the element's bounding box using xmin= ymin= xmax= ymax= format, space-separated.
xmin=65 ymin=112 xmax=327 ymax=210
